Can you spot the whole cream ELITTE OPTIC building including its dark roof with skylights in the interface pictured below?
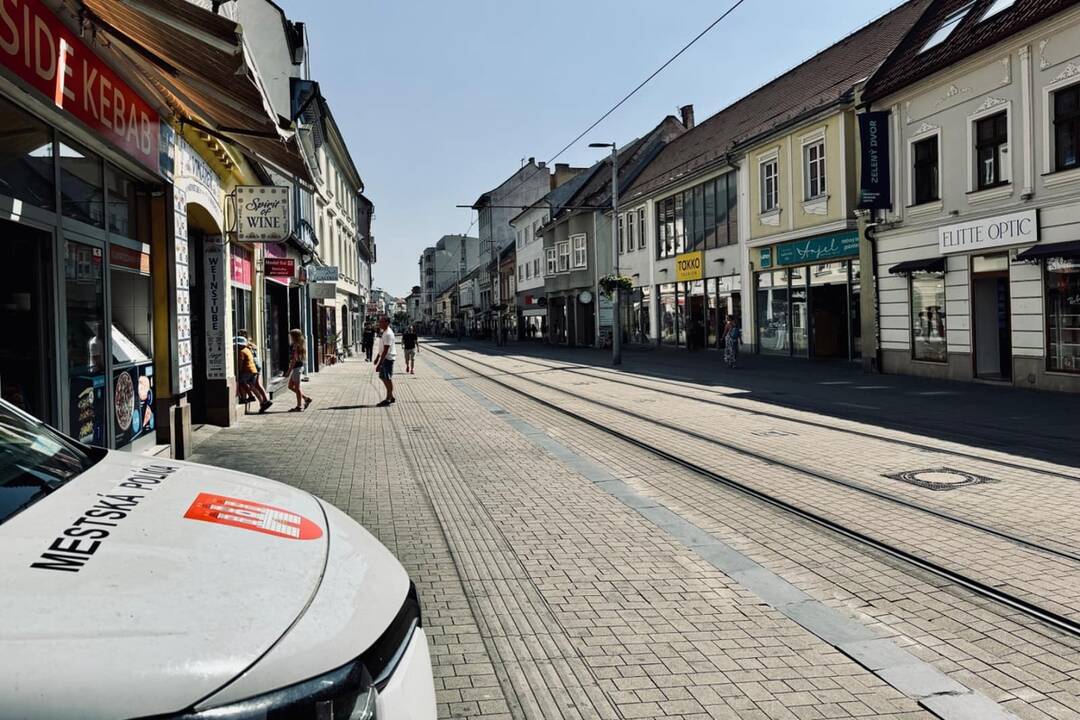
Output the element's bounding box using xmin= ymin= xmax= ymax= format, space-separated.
xmin=867 ymin=0 xmax=1080 ymax=392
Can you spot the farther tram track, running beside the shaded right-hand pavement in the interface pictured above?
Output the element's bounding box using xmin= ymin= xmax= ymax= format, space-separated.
xmin=436 ymin=345 xmax=1080 ymax=483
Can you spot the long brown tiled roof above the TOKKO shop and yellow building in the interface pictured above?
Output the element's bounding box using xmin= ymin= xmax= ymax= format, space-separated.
xmin=626 ymin=0 xmax=932 ymax=201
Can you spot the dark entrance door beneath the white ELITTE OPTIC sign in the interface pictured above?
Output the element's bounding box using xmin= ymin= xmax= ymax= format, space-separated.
xmin=972 ymin=255 xmax=1012 ymax=380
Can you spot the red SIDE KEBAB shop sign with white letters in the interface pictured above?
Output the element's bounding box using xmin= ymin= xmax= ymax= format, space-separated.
xmin=0 ymin=0 xmax=161 ymax=173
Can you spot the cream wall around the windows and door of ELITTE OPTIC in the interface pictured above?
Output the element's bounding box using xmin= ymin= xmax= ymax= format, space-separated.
xmin=876 ymin=5 xmax=1080 ymax=392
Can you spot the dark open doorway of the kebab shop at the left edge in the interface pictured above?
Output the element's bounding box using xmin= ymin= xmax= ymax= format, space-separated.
xmin=0 ymin=220 xmax=53 ymax=426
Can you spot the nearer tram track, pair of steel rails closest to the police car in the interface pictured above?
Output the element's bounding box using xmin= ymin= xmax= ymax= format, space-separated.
xmin=428 ymin=345 xmax=1080 ymax=638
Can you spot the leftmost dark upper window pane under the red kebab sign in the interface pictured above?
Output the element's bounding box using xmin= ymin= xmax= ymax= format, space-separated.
xmin=0 ymin=95 xmax=56 ymax=209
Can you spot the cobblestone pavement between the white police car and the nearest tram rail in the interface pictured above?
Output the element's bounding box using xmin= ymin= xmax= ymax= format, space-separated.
xmin=185 ymin=353 xmax=1080 ymax=718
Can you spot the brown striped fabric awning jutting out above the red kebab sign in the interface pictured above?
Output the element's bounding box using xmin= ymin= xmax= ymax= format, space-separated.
xmin=82 ymin=0 xmax=312 ymax=184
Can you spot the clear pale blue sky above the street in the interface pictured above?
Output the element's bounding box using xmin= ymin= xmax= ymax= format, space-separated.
xmin=279 ymin=0 xmax=900 ymax=296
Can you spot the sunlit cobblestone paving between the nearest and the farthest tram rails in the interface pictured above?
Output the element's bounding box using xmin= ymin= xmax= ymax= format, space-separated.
xmin=427 ymin=351 xmax=1080 ymax=620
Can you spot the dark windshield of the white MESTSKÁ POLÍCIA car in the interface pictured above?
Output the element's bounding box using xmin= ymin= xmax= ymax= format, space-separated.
xmin=0 ymin=400 xmax=96 ymax=522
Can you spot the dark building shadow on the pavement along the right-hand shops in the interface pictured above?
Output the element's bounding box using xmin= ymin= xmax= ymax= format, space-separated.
xmin=432 ymin=341 xmax=1080 ymax=466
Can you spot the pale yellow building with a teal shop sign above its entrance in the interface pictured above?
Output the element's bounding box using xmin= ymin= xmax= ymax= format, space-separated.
xmin=743 ymin=107 xmax=873 ymax=359
